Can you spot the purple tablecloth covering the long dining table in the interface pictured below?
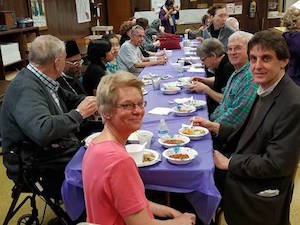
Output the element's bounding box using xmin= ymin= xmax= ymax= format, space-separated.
xmin=62 ymin=45 xmax=221 ymax=224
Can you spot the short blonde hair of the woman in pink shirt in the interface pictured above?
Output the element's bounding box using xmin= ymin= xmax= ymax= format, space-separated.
xmin=96 ymin=70 xmax=144 ymax=119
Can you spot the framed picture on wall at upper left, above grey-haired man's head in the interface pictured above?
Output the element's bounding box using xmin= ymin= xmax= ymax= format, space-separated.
xmin=28 ymin=0 xmax=48 ymax=30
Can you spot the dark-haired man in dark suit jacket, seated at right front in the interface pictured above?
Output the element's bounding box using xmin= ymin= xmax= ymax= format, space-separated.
xmin=192 ymin=31 xmax=300 ymax=225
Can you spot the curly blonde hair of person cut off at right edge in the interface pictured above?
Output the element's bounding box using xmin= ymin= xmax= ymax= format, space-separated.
xmin=282 ymin=6 xmax=300 ymax=31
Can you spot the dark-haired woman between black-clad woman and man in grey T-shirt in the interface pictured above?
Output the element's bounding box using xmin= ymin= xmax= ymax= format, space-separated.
xmin=102 ymin=34 xmax=120 ymax=73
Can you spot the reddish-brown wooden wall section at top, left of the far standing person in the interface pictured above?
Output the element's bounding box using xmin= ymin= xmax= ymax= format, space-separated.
xmin=106 ymin=0 xmax=134 ymax=33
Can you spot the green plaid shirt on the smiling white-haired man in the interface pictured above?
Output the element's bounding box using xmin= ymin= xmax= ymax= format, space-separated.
xmin=210 ymin=63 xmax=258 ymax=127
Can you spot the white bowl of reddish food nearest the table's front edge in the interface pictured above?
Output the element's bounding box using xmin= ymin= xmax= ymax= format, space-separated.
xmin=162 ymin=147 xmax=198 ymax=164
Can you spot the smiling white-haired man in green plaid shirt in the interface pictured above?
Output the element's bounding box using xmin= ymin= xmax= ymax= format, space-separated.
xmin=192 ymin=31 xmax=258 ymax=195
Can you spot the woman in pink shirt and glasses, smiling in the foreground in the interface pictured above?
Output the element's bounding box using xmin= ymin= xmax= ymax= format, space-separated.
xmin=82 ymin=71 xmax=195 ymax=225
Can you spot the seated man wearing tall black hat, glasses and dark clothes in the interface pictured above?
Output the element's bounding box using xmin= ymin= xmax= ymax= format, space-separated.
xmin=56 ymin=40 xmax=86 ymax=94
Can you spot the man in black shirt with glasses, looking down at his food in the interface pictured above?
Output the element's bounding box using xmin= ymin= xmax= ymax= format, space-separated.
xmin=189 ymin=38 xmax=234 ymax=116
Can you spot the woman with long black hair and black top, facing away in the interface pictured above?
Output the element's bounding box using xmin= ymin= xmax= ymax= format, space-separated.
xmin=82 ymin=39 xmax=114 ymax=95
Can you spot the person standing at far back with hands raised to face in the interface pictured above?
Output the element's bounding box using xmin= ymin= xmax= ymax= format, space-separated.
xmin=159 ymin=0 xmax=179 ymax=34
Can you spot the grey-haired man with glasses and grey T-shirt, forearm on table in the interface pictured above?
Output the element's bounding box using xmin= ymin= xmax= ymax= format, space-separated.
xmin=118 ymin=25 xmax=166 ymax=76
